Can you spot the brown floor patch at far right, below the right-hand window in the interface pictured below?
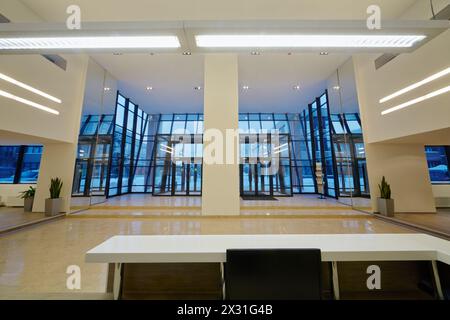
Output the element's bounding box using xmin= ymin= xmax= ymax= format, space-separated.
xmin=394 ymin=208 xmax=450 ymax=237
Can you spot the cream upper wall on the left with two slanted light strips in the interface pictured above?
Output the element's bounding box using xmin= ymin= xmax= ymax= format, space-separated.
xmin=0 ymin=55 xmax=88 ymax=143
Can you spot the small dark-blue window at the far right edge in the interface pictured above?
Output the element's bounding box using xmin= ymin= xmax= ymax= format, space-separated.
xmin=425 ymin=146 xmax=450 ymax=184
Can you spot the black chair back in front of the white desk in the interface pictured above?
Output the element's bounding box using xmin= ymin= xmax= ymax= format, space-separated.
xmin=224 ymin=249 xmax=322 ymax=300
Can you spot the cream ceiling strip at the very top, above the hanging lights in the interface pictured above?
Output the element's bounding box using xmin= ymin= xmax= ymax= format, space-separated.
xmin=18 ymin=0 xmax=418 ymax=21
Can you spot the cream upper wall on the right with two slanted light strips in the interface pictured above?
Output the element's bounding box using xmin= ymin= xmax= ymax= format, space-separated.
xmin=354 ymin=30 xmax=450 ymax=144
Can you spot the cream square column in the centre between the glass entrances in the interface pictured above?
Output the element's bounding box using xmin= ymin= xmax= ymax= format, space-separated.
xmin=202 ymin=54 xmax=240 ymax=215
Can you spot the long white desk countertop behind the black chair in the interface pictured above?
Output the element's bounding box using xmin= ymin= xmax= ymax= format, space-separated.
xmin=86 ymin=234 xmax=450 ymax=264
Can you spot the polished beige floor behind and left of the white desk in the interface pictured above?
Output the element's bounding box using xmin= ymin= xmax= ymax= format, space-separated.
xmin=0 ymin=211 xmax=412 ymax=299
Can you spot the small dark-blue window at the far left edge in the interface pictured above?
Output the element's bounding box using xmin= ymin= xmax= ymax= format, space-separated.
xmin=0 ymin=145 xmax=42 ymax=184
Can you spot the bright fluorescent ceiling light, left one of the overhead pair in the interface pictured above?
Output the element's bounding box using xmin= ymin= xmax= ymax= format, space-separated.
xmin=0 ymin=36 xmax=180 ymax=50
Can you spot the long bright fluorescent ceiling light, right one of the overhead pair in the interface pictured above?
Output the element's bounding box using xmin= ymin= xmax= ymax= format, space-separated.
xmin=195 ymin=34 xmax=426 ymax=48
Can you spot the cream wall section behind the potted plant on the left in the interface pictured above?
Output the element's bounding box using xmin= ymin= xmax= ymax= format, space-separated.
xmin=33 ymin=143 xmax=77 ymax=213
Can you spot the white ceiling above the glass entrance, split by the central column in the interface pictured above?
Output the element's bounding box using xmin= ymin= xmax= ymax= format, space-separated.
xmin=92 ymin=53 xmax=349 ymax=113
